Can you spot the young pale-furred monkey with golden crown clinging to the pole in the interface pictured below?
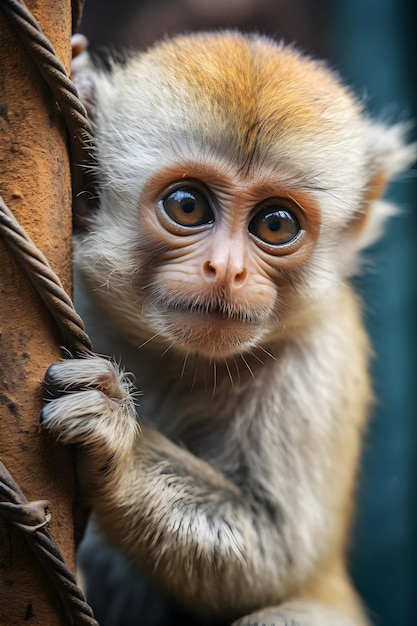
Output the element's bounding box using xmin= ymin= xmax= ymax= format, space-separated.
xmin=40 ymin=31 xmax=415 ymax=626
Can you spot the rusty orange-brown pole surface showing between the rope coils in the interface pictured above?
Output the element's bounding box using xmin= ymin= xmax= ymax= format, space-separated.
xmin=0 ymin=0 xmax=74 ymax=626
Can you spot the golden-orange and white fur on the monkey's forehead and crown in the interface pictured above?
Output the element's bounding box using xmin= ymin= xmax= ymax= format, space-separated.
xmin=93 ymin=32 xmax=365 ymax=197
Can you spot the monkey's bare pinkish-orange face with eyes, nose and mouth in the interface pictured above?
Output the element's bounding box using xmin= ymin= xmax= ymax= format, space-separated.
xmin=130 ymin=160 xmax=319 ymax=359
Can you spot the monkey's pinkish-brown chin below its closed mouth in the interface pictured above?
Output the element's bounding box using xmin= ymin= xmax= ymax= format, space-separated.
xmin=162 ymin=313 xmax=263 ymax=359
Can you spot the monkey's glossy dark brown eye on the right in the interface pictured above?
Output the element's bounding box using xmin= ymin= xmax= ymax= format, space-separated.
xmin=249 ymin=202 xmax=301 ymax=247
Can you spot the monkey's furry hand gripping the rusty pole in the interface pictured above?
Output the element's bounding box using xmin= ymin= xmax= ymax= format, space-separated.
xmin=39 ymin=357 xmax=139 ymax=490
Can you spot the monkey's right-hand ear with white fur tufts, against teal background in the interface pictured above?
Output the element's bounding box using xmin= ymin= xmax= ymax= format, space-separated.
xmin=351 ymin=121 xmax=417 ymax=250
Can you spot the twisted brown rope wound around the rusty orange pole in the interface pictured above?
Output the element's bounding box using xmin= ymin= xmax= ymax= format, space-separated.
xmin=0 ymin=0 xmax=98 ymax=626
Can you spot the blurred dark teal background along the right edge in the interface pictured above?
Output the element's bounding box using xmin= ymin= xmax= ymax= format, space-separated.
xmin=329 ymin=0 xmax=417 ymax=626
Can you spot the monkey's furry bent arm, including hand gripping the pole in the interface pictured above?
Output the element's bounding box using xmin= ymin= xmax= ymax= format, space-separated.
xmin=41 ymin=358 xmax=300 ymax=615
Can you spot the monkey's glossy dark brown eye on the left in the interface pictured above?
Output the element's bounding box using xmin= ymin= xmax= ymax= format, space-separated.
xmin=162 ymin=188 xmax=214 ymax=228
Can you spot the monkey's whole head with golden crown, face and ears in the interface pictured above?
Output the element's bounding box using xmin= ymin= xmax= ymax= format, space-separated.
xmin=75 ymin=33 xmax=414 ymax=358
